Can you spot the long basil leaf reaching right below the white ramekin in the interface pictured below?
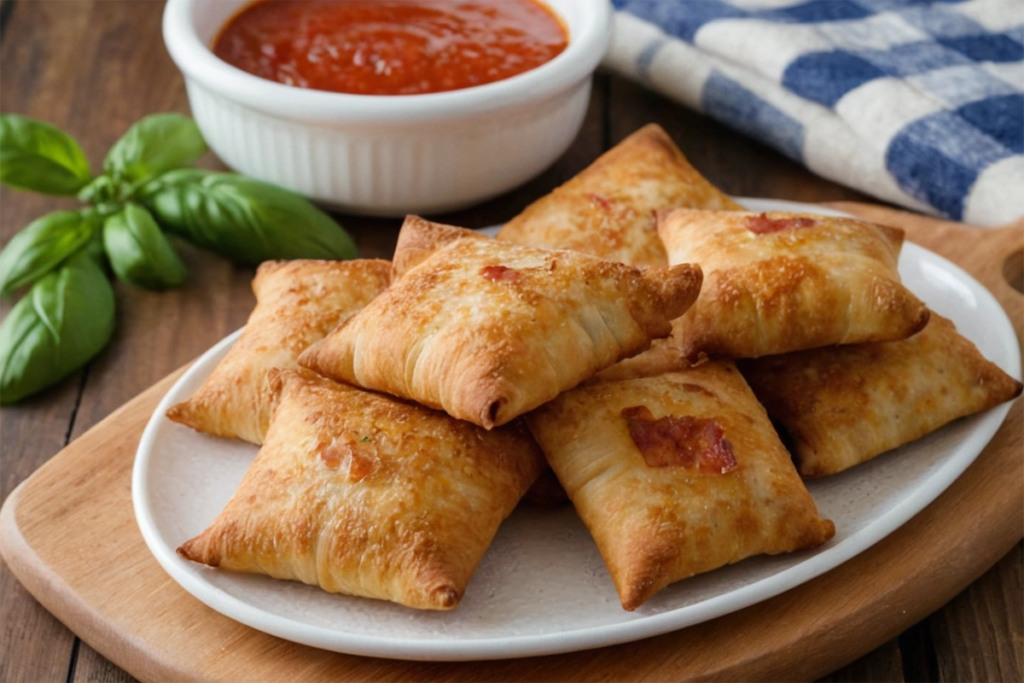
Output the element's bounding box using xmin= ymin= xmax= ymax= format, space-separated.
xmin=141 ymin=169 xmax=356 ymax=264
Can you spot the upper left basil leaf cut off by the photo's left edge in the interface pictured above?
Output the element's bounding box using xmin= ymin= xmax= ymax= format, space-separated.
xmin=0 ymin=114 xmax=92 ymax=195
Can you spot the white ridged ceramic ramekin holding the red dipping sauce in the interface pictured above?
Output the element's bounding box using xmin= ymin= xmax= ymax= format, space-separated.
xmin=164 ymin=0 xmax=612 ymax=216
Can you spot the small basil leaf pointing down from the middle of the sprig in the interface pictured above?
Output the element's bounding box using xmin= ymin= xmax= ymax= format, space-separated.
xmin=103 ymin=204 xmax=185 ymax=290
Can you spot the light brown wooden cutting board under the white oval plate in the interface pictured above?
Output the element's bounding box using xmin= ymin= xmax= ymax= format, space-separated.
xmin=0 ymin=204 xmax=1024 ymax=683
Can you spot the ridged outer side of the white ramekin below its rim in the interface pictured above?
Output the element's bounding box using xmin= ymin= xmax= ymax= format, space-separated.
xmin=185 ymin=78 xmax=591 ymax=216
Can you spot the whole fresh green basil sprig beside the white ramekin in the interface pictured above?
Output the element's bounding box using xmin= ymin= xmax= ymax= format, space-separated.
xmin=0 ymin=109 xmax=356 ymax=403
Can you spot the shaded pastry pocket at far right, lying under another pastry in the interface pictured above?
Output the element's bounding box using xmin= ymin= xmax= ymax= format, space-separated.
xmin=740 ymin=312 xmax=1021 ymax=477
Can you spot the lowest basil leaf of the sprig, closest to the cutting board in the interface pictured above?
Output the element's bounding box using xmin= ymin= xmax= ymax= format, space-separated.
xmin=0 ymin=251 xmax=114 ymax=403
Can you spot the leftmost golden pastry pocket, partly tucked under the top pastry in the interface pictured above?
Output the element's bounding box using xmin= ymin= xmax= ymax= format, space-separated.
xmin=167 ymin=259 xmax=391 ymax=444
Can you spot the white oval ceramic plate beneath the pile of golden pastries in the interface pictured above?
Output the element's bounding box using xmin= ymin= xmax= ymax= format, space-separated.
xmin=132 ymin=200 xmax=1020 ymax=660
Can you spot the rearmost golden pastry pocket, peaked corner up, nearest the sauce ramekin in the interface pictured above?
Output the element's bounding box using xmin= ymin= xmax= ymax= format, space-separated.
xmin=498 ymin=124 xmax=742 ymax=266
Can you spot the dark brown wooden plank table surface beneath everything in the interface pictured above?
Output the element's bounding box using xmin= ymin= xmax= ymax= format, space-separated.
xmin=0 ymin=0 xmax=1024 ymax=683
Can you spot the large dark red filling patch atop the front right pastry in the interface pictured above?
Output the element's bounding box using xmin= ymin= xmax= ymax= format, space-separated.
xmin=623 ymin=405 xmax=737 ymax=474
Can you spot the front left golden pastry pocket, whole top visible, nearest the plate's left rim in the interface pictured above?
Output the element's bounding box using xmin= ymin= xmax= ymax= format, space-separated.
xmin=178 ymin=370 xmax=544 ymax=609
